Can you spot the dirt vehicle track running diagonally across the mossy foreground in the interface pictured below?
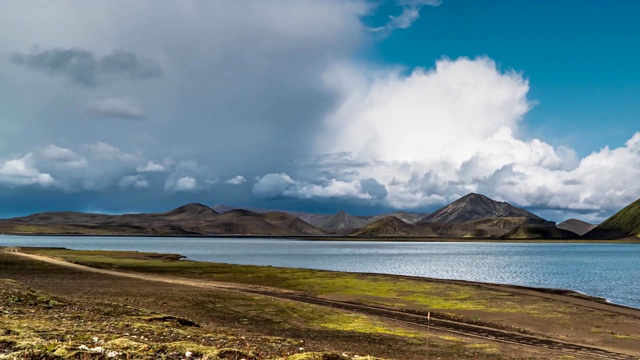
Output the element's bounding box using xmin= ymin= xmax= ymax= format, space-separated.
xmin=6 ymin=251 xmax=640 ymax=360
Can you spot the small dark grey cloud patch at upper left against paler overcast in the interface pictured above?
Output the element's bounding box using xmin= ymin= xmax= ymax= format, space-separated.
xmin=11 ymin=48 xmax=163 ymax=86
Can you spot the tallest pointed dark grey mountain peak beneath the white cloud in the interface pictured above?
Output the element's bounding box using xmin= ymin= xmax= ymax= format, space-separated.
xmin=419 ymin=193 xmax=544 ymax=223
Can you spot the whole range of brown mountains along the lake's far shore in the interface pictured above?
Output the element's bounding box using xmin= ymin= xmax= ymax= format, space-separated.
xmin=0 ymin=193 xmax=640 ymax=239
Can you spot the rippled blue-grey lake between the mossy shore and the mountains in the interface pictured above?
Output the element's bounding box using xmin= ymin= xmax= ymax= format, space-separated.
xmin=0 ymin=236 xmax=640 ymax=308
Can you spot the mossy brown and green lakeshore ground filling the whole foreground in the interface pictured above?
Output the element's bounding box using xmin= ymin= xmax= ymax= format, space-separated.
xmin=0 ymin=249 xmax=640 ymax=359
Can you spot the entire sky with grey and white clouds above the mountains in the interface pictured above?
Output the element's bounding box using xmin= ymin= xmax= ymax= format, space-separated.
xmin=0 ymin=0 xmax=640 ymax=223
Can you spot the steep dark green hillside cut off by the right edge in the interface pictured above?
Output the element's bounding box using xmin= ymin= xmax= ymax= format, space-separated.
xmin=583 ymin=199 xmax=640 ymax=239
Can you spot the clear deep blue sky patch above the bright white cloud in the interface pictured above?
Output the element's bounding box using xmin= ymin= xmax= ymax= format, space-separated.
xmin=371 ymin=0 xmax=640 ymax=156
